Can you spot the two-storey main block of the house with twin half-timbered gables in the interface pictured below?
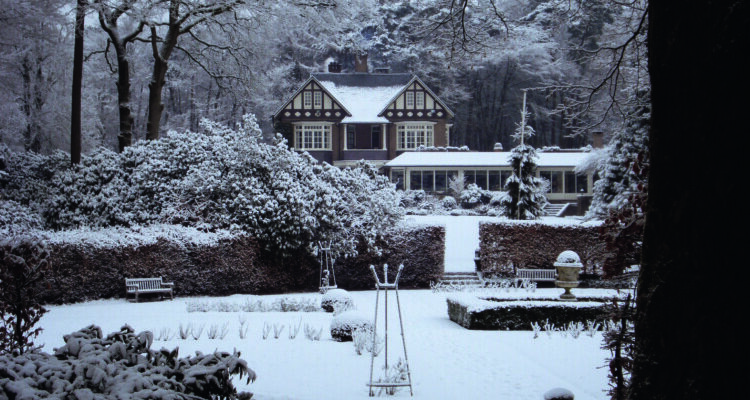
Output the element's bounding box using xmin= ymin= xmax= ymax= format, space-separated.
xmin=273 ymin=56 xmax=453 ymax=167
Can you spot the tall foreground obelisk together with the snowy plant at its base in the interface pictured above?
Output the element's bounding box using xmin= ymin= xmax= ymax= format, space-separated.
xmin=367 ymin=264 xmax=414 ymax=397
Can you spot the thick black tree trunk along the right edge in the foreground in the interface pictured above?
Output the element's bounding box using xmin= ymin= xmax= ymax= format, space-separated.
xmin=630 ymin=0 xmax=750 ymax=400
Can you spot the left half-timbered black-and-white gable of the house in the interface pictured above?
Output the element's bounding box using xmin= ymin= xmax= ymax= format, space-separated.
xmin=274 ymin=77 xmax=351 ymax=121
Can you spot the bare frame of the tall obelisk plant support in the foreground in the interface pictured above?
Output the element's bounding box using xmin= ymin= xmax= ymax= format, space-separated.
xmin=368 ymin=264 xmax=414 ymax=397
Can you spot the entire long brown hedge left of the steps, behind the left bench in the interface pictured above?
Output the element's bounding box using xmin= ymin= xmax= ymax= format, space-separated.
xmin=40 ymin=227 xmax=445 ymax=304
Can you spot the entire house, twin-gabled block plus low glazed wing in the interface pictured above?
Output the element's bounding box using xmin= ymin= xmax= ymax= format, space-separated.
xmin=273 ymin=55 xmax=601 ymax=211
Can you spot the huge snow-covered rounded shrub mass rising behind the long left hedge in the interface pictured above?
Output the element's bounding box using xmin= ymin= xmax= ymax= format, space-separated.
xmin=0 ymin=117 xmax=402 ymax=254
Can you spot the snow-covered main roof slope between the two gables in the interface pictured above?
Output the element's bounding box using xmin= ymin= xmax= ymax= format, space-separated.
xmin=314 ymin=74 xmax=412 ymax=123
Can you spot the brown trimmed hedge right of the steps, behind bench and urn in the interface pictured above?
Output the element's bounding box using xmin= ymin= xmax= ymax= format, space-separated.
xmin=478 ymin=222 xmax=606 ymax=276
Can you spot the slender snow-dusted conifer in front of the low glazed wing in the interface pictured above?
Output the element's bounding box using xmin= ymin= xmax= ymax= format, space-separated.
xmin=501 ymin=96 xmax=548 ymax=219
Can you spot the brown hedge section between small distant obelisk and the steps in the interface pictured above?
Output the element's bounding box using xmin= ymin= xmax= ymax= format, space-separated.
xmin=336 ymin=226 xmax=445 ymax=290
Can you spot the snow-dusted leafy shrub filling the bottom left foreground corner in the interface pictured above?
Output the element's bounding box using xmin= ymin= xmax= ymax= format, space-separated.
xmin=0 ymin=325 xmax=256 ymax=400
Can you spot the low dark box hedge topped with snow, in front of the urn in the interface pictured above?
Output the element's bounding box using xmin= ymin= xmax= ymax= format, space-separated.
xmin=446 ymin=297 xmax=610 ymax=331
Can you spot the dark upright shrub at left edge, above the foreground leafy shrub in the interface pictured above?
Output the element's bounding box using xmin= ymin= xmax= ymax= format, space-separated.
xmin=0 ymin=233 xmax=49 ymax=354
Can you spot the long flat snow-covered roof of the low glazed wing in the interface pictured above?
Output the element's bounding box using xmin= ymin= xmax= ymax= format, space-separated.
xmin=385 ymin=151 xmax=589 ymax=167
